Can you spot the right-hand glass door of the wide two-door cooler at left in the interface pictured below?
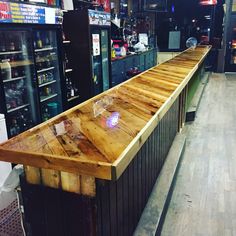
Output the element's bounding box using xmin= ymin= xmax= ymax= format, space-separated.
xmin=34 ymin=30 xmax=62 ymax=121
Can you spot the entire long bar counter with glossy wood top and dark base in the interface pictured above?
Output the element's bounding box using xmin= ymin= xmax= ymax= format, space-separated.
xmin=0 ymin=46 xmax=210 ymax=235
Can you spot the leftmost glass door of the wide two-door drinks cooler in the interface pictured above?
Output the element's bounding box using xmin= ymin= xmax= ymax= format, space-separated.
xmin=0 ymin=30 xmax=38 ymax=137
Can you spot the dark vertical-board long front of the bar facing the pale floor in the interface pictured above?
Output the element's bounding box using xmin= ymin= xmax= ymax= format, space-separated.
xmin=96 ymin=98 xmax=179 ymax=236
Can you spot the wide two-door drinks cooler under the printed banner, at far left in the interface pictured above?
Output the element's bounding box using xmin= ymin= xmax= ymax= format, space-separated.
xmin=0 ymin=1 xmax=62 ymax=137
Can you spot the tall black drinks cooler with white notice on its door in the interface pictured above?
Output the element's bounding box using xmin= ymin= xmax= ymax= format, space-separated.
xmin=63 ymin=9 xmax=111 ymax=102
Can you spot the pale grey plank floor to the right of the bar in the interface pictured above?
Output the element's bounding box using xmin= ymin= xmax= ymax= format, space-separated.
xmin=161 ymin=74 xmax=236 ymax=236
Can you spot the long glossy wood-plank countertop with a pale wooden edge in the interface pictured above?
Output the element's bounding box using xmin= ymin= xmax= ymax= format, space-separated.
xmin=0 ymin=46 xmax=210 ymax=183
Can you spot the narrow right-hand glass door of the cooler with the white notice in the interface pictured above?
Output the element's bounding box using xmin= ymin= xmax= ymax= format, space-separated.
xmin=101 ymin=30 xmax=109 ymax=91
